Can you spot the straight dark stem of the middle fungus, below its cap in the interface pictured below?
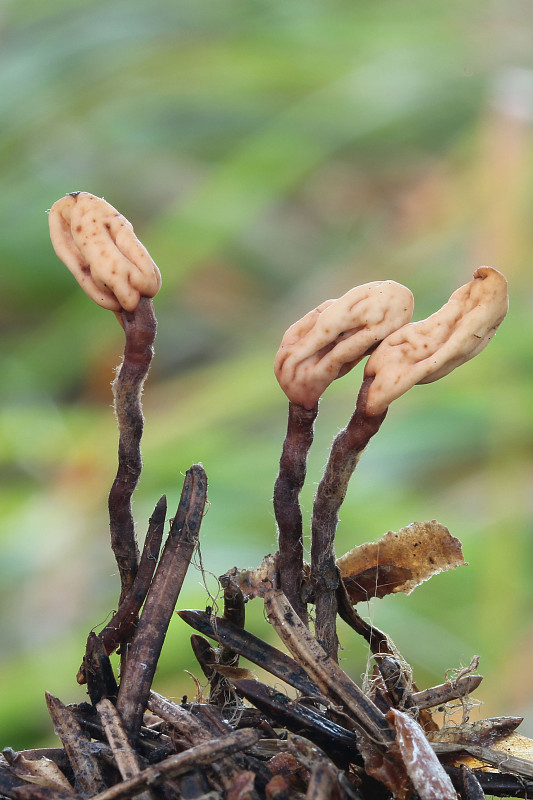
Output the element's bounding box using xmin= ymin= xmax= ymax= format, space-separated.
xmin=274 ymin=402 xmax=318 ymax=625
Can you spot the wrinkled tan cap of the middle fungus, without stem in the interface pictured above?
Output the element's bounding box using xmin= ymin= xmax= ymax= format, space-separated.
xmin=274 ymin=281 xmax=413 ymax=409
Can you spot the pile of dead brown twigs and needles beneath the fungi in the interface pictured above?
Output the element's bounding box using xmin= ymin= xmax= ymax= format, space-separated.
xmin=0 ymin=465 xmax=533 ymax=800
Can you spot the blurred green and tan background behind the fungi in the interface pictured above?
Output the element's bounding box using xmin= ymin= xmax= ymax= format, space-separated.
xmin=0 ymin=0 xmax=533 ymax=748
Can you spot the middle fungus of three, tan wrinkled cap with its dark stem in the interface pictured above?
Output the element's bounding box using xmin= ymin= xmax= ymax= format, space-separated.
xmin=274 ymin=281 xmax=413 ymax=622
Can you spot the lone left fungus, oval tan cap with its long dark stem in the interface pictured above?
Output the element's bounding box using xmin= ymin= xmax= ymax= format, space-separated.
xmin=49 ymin=192 xmax=161 ymax=620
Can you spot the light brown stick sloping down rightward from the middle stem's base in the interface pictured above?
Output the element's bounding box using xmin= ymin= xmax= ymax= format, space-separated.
xmin=265 ymin=589 xmax=394 ymax=749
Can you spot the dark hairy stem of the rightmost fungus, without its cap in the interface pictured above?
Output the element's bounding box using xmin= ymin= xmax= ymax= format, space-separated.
xmin=311 ymin=378 xmax=387 ymax=661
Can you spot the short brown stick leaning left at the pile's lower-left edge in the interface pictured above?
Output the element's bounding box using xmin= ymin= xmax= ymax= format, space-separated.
xmin=45 ymin=692 xmax=105 ymax=797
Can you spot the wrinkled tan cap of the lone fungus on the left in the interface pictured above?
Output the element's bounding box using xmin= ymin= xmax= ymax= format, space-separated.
xmin=49 ymin=192 xmax=161 ymax=312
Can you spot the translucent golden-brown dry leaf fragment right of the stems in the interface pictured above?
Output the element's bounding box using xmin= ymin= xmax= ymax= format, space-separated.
xmin=337 ymin=520 xmax=466 ymax=603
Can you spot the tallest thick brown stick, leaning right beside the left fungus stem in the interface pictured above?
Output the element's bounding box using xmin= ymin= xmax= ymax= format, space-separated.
xmin=117 ymin=464 xmax=207 ymax=738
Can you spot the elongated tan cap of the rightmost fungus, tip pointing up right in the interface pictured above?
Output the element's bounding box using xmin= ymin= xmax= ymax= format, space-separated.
xmin=365 ymin=267 xmax=509 ymax=416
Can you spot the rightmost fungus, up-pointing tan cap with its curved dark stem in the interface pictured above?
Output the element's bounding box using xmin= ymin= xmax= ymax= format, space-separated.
xmin=311 ymin=267 xmax=508 ymax=657
